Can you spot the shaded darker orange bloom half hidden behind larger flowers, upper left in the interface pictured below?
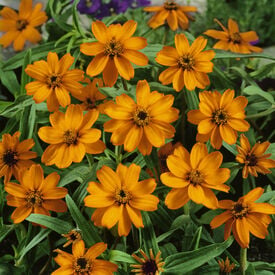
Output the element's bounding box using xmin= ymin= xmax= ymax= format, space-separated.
xmin=75 ymin=78 xmax=106 ymax=113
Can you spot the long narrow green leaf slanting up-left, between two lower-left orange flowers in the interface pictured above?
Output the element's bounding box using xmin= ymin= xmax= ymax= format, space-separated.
xmin=66 ymin=195 xmax=102 ymax=247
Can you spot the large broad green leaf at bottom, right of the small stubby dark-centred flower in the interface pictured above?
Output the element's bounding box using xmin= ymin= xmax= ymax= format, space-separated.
xmin=163 ymin=236 xmax=234 ymax=275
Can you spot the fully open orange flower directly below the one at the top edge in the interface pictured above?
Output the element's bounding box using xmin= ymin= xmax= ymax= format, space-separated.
xmin=156 ymin=34 xmax=215 ymax=92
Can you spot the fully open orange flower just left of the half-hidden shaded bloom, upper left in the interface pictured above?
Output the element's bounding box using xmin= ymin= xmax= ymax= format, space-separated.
xmin=25 ymin=52 xmax=84 ymax=112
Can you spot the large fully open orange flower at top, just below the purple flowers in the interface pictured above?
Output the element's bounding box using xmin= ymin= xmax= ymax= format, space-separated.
xmin=80 ymin=20 xmax=148 ymax=87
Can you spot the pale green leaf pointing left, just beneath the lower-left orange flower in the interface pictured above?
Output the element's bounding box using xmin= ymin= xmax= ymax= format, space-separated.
xmin=26 ymin=214 xmax=73 ymax=234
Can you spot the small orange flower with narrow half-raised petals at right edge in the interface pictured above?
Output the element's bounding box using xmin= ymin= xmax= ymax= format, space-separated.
xmin=236 ymin=134 xmax=275 ymax=178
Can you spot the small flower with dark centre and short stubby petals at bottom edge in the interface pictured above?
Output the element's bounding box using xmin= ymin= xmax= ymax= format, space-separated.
xmin=131 ymin=248 xmax=165 ymax=275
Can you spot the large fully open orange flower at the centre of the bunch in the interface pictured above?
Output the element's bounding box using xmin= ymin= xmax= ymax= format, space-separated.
xmin=104 ymin=80 xmax=178 ymax=155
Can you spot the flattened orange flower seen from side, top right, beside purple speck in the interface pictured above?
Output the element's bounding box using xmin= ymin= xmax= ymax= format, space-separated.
xmin=204 ymin=18 xmax=262 ymax=53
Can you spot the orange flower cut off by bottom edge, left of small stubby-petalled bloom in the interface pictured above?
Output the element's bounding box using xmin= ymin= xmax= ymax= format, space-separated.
xmin=51 ymin=240 xmax=117 ymax=275
